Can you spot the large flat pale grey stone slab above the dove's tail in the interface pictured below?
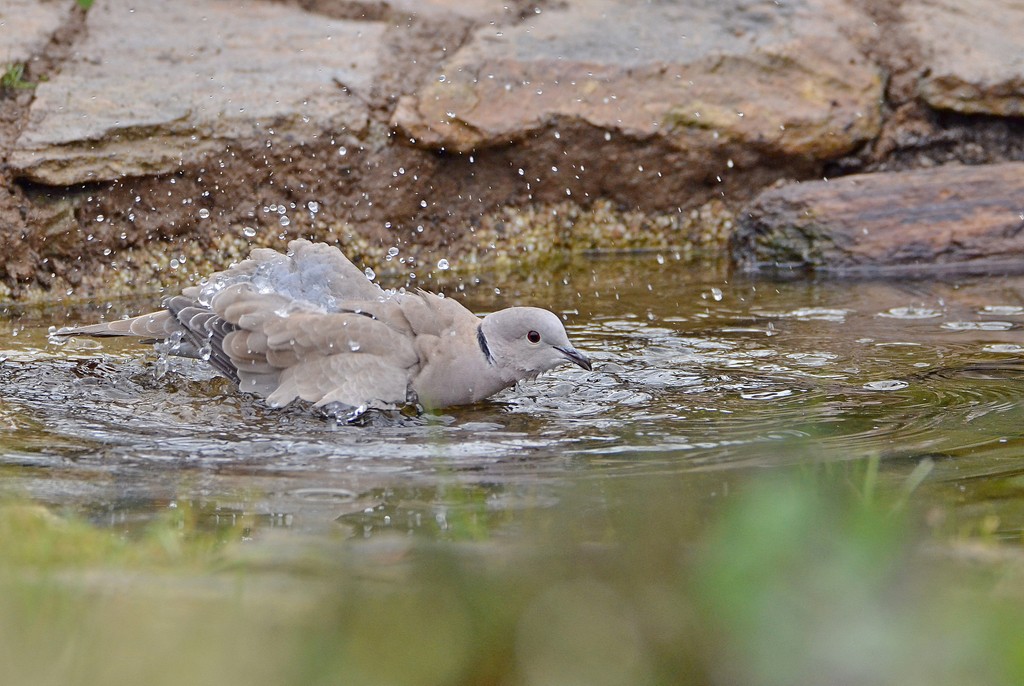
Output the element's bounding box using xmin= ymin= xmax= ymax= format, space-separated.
xmin=9 ymin=0 xmax=384 ymax=185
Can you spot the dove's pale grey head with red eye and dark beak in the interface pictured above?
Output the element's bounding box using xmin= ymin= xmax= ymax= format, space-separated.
xmin=480 ymin=307 xmax=591 ymax=379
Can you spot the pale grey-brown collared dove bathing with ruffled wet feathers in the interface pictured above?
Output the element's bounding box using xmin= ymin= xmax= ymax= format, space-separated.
xmin=56 ymin=240 xmax=591 ymax=410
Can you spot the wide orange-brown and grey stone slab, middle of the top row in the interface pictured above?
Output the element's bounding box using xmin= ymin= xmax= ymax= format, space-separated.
xmin=394 ymin=0 xmax=882 ymax=159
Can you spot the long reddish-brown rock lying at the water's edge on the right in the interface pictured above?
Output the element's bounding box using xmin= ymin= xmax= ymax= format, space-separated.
xmin=732 ymin=163 xmax=1024 ymax=275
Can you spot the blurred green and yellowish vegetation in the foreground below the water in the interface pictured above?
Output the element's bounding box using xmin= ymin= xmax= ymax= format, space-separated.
xmin=0 ymin=462 xmax=1024 ymax=686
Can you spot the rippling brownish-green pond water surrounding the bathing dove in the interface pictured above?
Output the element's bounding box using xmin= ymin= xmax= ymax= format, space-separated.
xmin=0 ymin=255 xmax=1024 ymax=540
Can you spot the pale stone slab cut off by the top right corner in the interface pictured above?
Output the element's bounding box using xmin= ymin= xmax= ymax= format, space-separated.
xmin=901 ymin=0 xmax=1024 ymax=117
